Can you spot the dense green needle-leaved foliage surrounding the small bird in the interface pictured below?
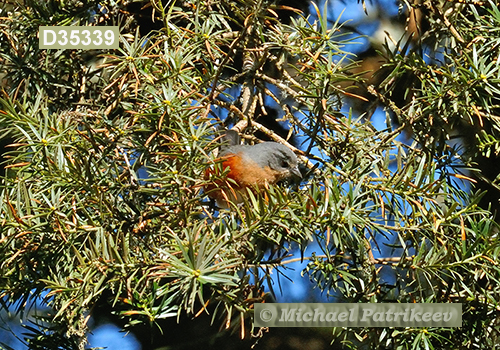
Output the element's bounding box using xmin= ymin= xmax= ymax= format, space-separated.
xmin=0 ymin=0 xmax=500 ymax=349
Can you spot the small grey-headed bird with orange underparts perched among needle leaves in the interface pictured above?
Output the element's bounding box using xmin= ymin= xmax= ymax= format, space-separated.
xmin=205 ymin=130 xmax=302 ymax=209
